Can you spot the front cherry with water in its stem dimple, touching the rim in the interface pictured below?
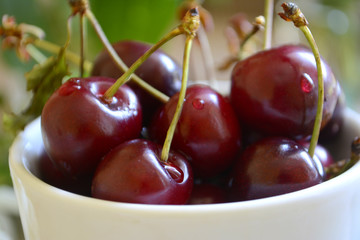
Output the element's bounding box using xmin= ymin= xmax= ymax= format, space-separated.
xmin=92 ymin=139 xmax=193 ymax=204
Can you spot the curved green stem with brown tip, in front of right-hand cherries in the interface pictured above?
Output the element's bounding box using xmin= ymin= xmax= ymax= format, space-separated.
xmin=279 ymin=3 xmax=324 ymax=157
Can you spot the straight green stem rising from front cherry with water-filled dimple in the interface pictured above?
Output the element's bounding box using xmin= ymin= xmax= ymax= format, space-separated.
xmin=161 ymin=8 xmax=200 ymax=162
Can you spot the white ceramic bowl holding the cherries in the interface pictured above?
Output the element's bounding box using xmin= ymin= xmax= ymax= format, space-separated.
xmin=10 ymin=109 xmax=360 ymax=240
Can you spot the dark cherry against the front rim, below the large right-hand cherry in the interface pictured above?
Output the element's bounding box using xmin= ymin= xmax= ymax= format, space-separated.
xmin=230 ymin=137 xmax=323 ymax=201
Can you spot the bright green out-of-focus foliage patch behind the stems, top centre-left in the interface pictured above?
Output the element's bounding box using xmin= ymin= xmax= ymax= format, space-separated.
xmin=89 ymin=0 xmax=182 ymax=57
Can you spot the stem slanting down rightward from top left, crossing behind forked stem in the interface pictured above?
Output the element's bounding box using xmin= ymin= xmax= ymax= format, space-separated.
xmin=85 ymin=8 xmax=169 ymax=103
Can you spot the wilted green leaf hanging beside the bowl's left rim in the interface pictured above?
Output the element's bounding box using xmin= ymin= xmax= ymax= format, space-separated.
xmin=3 ymin=49 xmax=69 ymax=134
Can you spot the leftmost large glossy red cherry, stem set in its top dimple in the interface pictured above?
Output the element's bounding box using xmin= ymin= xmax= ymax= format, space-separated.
xmin=41 ymin=77 xmax=142 ymax=181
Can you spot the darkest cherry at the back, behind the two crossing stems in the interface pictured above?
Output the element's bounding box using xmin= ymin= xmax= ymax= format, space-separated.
xmin=91 ymin=40 xmax=182 ymax=124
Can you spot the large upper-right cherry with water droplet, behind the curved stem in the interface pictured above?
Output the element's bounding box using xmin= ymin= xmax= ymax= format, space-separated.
xmin=230 ymin=45 xmax=337 ymax=138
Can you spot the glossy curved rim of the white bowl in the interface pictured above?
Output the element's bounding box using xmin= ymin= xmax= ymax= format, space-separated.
xmin=9 ymin=109 xmax=360 ymax=216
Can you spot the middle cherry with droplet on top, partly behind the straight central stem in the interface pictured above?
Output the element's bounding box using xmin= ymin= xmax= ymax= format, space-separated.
xmin=149 ymin=84 xmax=241 ymax=178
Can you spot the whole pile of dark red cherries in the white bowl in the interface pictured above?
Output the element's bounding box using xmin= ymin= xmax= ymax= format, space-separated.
xmin=41 ymin=33 xmax=344 ymax=204
